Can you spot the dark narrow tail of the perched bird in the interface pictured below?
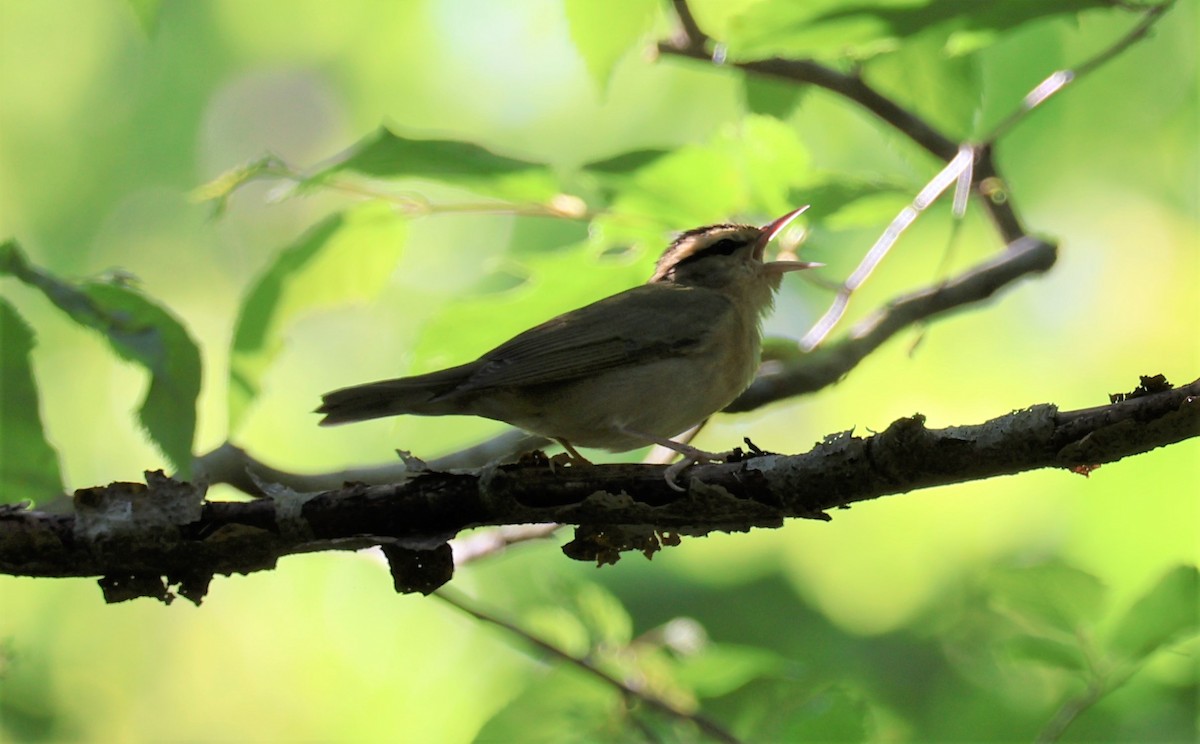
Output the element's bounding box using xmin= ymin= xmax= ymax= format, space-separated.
xmin=316 ymin=364 xmax=475 ymax=426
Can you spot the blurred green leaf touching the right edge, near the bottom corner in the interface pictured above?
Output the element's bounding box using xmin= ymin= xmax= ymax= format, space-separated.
xmin=1112 ymin=565 xmax=1200 ymax=661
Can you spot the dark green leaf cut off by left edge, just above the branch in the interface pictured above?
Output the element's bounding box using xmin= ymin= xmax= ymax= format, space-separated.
xmin=0 ymin=299 xmax=62 ymax=503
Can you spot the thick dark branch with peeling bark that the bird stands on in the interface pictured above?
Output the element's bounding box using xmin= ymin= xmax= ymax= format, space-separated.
xmin=0 ymin=378 xmax=1200 ymax=601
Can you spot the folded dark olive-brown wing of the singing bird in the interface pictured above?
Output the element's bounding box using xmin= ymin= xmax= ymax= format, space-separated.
xmin=454 ymin=284 xmax=732 ymax=395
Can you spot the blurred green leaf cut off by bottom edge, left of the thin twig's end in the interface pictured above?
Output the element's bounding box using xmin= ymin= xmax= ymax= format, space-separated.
xmin=475 ymin=666 xmax=631 ymax=744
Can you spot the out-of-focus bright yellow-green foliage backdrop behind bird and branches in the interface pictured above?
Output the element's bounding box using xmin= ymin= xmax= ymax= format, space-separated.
xmin=0 ymin=0 xmax=1200 ymax=742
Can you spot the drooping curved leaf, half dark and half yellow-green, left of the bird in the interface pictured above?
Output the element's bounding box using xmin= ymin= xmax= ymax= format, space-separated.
xmin=229 ymin=204 xmax=408 ymax=431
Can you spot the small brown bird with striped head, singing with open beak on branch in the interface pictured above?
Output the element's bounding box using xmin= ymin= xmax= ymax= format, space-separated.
xmin=316 ymin=206 xmax=822 ymax=482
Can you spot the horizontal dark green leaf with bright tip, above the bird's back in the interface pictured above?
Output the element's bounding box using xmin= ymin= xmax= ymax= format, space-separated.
xmin=307 ymin=127 xmax=558 ymax=200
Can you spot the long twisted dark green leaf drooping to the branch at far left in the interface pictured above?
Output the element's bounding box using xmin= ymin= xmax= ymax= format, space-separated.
xmin=0 ymin=241 xmax=200 ymax=478
